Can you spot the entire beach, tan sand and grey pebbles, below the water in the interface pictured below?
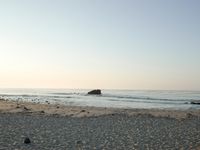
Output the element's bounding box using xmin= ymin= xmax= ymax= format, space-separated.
xmin=0 ymin=99 xmax=200 ymax=150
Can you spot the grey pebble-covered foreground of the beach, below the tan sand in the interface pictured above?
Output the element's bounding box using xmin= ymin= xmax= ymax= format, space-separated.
xmin=0 ymin=113 xmax=200 ymax=150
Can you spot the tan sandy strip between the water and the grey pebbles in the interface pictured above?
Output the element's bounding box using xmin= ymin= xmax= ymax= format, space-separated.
xmin=0 ymin=99 xmax=200 ymax=119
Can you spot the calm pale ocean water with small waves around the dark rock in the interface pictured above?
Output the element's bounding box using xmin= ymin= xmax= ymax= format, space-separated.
xmin=0 ymin=89 xmax=200 ymax=110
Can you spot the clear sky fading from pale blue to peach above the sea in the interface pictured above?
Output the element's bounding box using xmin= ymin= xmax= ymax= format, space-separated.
xmin=0 ymin=0 xmax=200 ymax=90
